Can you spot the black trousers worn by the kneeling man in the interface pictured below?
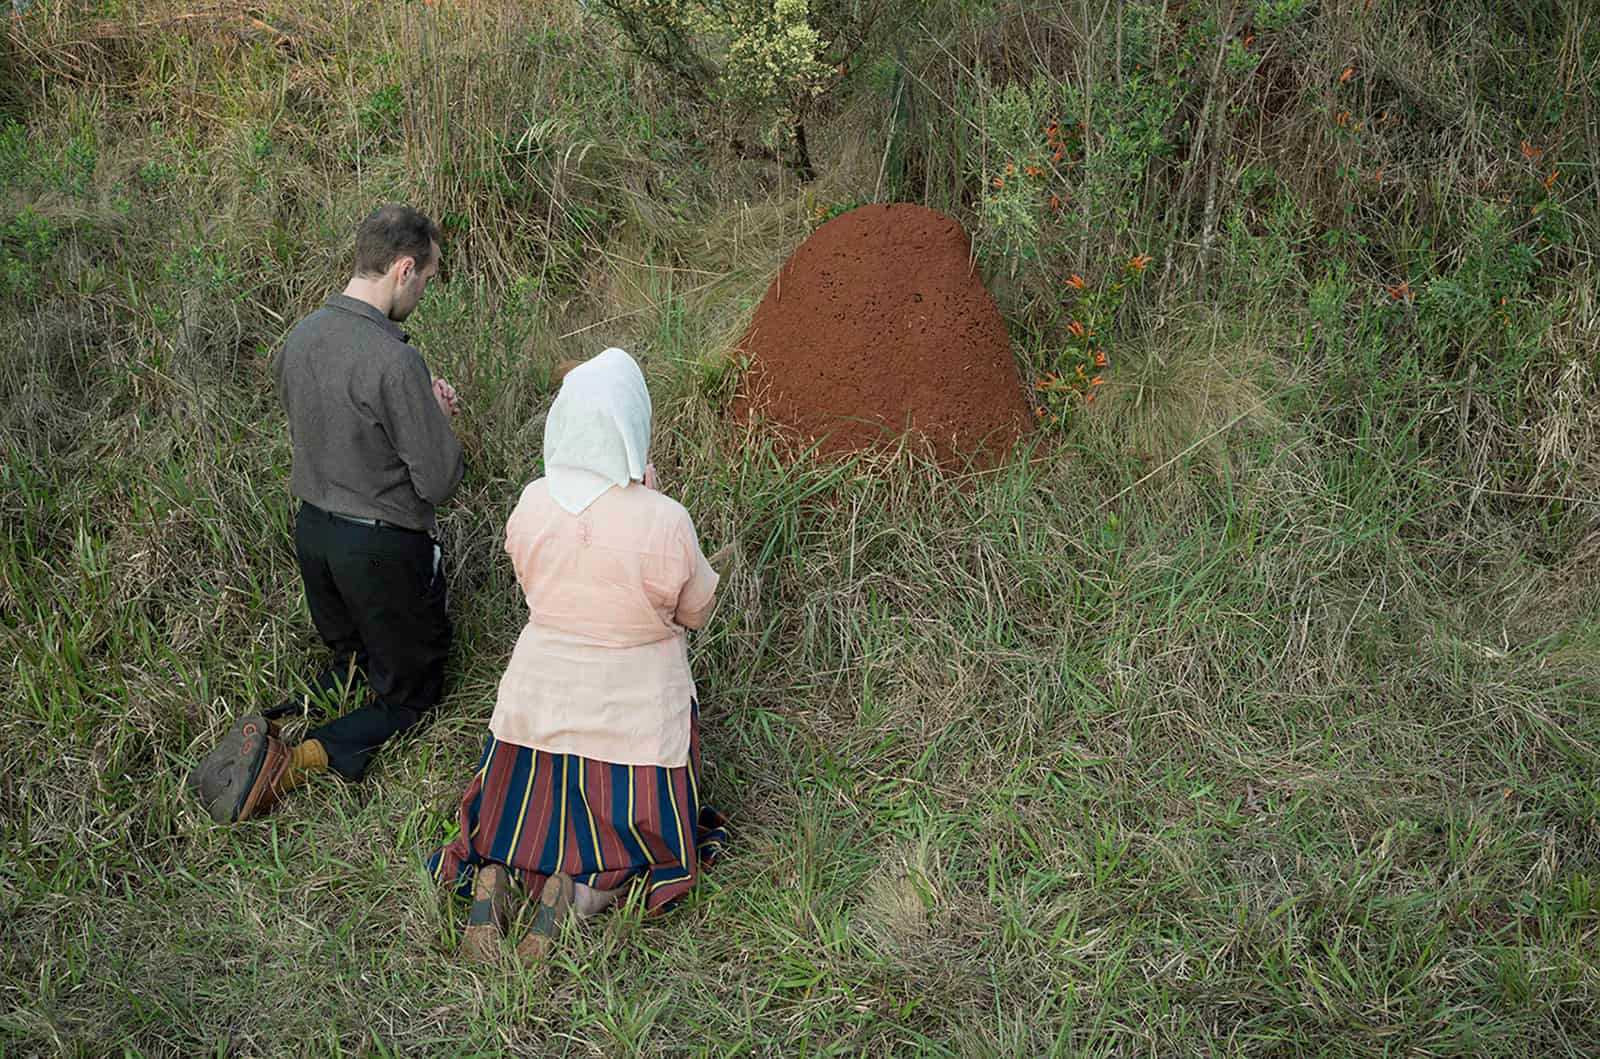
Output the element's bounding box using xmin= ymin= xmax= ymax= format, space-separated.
xmin=294 ymin=504 xmax=451 ymax=781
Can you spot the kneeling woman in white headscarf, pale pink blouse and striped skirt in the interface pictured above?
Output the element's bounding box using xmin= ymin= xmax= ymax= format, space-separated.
xmin=429 ymin=349 xmax=726 ymax=958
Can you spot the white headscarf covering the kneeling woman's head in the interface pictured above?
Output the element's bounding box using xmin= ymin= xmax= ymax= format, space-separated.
xmin=544 ymin=349 xmax=651 ymax=515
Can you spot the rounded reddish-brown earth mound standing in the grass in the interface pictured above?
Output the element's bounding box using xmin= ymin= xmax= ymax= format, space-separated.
xmin=734 ymin=205 xmax=1029 ymax=462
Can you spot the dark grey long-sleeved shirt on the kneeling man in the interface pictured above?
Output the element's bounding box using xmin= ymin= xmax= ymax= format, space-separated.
xmin=274 ymin=294 xmax=464 ymax=530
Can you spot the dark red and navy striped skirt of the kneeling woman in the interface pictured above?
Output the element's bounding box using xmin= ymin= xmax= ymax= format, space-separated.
xmin=427 ymin=707 xmax=728 ymax=912
